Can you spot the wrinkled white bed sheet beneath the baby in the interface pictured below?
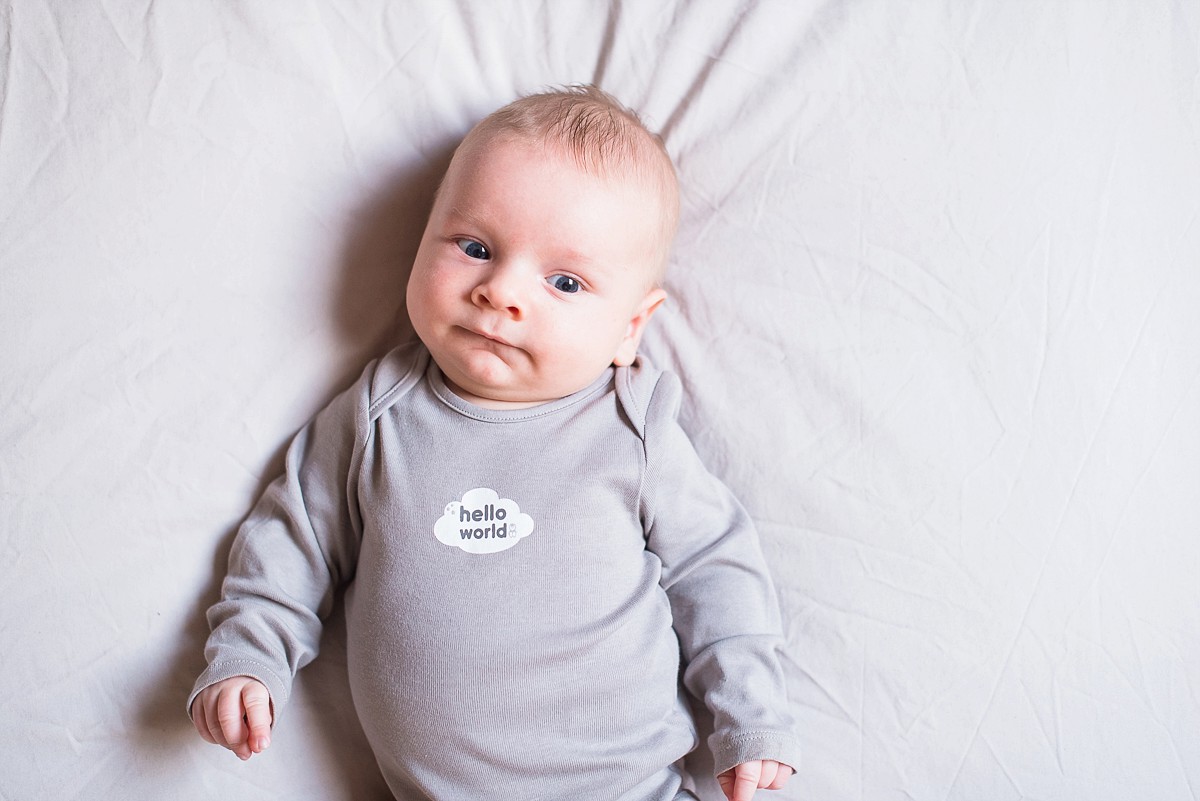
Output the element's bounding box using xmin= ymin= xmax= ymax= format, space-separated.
xmin=0 ymin=0 xmax=1200 ymax=801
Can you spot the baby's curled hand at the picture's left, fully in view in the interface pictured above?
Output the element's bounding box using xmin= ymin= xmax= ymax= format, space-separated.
xmin=192 ymin=676 xmax=274 ymax=760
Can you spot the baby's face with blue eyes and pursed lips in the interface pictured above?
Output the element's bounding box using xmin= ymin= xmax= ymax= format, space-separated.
xmin=408 ymin=139 xmax=666 ymax=408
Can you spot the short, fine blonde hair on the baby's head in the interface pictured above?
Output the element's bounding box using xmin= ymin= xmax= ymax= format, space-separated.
xmin=456 ymin=85 xmax=679 ymax=281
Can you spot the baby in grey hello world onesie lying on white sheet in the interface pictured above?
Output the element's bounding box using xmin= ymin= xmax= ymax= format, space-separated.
xmin=188 ymin=88 xmax=798 ymax=801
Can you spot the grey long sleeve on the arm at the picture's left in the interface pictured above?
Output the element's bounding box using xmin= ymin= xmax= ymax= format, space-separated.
xmin=187 ymin=368 xmax=372 ymax=715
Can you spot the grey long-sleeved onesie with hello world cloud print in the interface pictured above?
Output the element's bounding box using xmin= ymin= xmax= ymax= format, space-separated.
xmin=188 ymin=345 xmax=798 ymax=801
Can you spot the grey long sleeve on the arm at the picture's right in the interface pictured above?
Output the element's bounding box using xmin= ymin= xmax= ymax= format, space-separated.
xmin=643 ymin=374 xmax=799 ymax=773
